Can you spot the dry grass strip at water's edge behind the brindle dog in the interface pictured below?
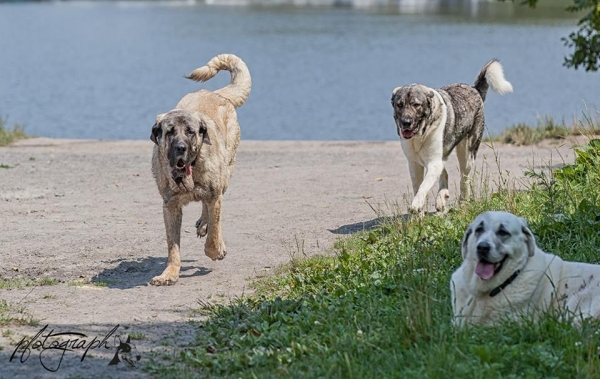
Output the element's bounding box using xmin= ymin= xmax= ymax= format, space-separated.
xmin=486 ymin=116 xmax=600 ymax=146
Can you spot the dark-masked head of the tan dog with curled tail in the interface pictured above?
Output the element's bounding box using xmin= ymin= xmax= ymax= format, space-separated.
xmin=150 ymin=110 xmax=210 ymax=184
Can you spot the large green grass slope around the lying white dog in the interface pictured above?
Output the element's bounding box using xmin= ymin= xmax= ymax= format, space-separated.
xmin=145 ymin=140 xmax=600 ymax=379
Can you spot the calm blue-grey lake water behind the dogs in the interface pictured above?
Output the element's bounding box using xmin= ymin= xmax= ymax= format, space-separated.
xmin=0 ymin=0 xmax=600 ymax=140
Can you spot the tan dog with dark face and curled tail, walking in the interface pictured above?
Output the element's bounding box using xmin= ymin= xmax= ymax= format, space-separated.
xmin=150 ymin=54 xmax=252 ymax=285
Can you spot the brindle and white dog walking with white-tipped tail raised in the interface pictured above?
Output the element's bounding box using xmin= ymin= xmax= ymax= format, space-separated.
xmin=392 ymin=59 xmax=513 ymax=214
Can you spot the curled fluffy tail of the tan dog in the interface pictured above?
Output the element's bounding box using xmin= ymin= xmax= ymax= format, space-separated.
xmin=187 ymin=54 xmax=252 ymax=108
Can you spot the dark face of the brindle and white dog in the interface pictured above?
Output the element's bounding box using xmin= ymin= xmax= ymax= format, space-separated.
xmin=392 ymin=85 xmax=434 ymax=140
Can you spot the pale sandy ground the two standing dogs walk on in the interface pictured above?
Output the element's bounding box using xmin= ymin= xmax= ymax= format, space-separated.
xmin=0 ymin=138 xmax=573 ymax=378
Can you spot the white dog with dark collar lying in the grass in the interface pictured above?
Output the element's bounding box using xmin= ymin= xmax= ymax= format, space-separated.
xmin=450 ymin=212 xmax=600 ymax=325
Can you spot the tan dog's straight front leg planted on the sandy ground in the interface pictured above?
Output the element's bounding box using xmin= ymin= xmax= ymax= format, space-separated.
xmin=150 ymin=204 xmax=183 ymax=286
